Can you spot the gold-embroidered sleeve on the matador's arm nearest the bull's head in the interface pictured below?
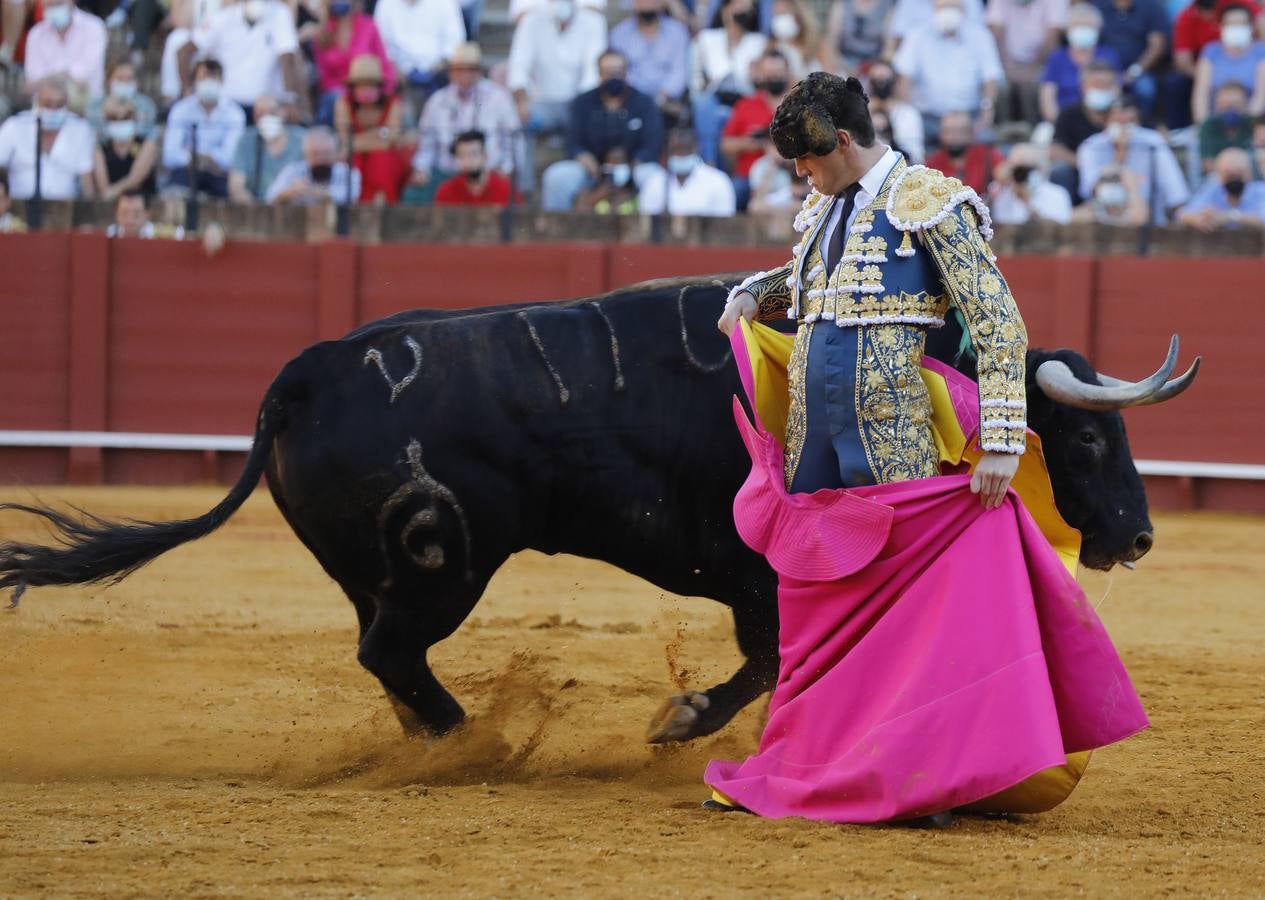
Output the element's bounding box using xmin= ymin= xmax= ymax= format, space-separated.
xmin=898 ymin=167 xmax=1027 ymax=453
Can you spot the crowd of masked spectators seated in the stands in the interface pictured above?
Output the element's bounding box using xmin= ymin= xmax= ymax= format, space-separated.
xmin=0 ymin=0 xmax=1265 ymax=233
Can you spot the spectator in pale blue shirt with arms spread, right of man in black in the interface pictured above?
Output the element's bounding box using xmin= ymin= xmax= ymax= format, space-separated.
xmin=1077 ymin=96 xmax=1190 ymax=225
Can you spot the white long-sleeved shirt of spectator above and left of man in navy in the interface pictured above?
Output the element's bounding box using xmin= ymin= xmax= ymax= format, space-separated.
xmin=506 ymin=5 xmax=606 ymax=103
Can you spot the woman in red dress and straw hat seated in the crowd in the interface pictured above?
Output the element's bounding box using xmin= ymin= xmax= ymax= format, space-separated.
xmin=334 ymin=53 xmax=410 ymax=204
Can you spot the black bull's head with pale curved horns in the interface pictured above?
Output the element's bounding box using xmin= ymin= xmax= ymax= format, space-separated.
xmin=1027 ymin=335 xmax=1199 ymax=570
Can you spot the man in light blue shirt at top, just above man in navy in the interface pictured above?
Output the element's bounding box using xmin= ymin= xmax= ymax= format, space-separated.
xmin=611 ymin=0 xmax=689 ymax=106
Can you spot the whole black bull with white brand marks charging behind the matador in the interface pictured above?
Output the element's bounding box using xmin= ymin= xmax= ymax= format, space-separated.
xmin=0 ymin=280 xmax=1195 ymax=741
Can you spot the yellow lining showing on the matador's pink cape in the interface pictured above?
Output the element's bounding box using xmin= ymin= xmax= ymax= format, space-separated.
xmin=740 ymin=320 xmax=1089 ymax=813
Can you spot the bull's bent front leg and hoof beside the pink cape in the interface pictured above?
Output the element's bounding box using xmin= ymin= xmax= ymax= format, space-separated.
xmin=646 ymin=597 xmax=778 ymax=744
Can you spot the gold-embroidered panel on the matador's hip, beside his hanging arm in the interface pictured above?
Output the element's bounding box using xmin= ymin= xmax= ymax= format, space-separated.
xmin=855 ymin=324 xmax=940 ymax=485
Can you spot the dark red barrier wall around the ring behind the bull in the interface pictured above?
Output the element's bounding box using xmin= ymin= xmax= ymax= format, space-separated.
xmin=0 ymin=232 xmax=1265 ymax=511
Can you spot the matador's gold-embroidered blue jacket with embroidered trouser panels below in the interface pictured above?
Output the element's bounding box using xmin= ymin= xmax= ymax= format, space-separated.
xmin=735 ymin=159 xmax=1027 ymax=486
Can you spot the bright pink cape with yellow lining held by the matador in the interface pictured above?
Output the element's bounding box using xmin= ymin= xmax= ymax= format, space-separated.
xmin=705 ymin=323 xmax=1147 ymax=823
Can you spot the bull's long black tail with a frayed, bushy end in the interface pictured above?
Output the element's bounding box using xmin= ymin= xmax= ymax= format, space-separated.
xmin=0 ymin=363 xmax=296 ymax=605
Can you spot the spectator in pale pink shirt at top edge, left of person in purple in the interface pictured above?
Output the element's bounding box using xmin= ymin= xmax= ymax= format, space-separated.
xmin=987 ymin=0 xmax=1068 ymax=122
